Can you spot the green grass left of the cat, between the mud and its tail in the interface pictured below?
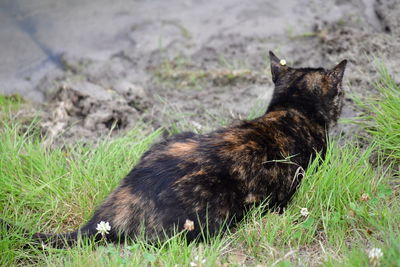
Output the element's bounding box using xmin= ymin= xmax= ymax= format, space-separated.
xmin=0 ymin=123 xmax=160 ymax=263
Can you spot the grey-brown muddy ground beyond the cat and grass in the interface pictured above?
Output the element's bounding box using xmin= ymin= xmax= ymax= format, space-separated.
xmin=0 ymin=0 xmax=400 ymax=143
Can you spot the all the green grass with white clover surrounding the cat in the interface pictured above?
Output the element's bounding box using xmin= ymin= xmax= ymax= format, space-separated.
xmin=0 ymin=67 xmax=400 ymax=266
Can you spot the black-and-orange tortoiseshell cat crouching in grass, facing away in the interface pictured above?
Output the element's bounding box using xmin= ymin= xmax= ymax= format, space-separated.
xmin=3 ymin=52 xmax=347 ymax=247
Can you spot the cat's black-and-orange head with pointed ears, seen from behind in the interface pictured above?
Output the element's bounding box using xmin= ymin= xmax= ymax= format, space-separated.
xmin=269 ymin=51 xmax=347 ymax=130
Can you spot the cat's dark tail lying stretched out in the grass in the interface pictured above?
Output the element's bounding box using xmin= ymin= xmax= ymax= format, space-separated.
xmin=0 ymin=219 xmax=101 ymax=248
